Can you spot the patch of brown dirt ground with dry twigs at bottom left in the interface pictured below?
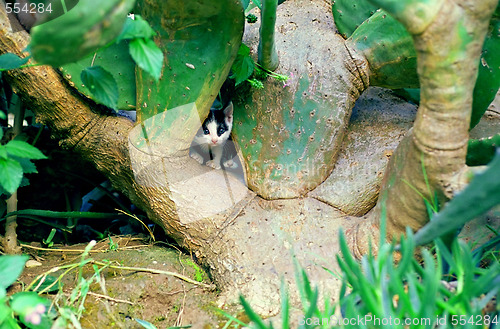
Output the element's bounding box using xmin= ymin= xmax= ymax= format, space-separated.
xmin=10 ymin=236 xmax=245 ymax=328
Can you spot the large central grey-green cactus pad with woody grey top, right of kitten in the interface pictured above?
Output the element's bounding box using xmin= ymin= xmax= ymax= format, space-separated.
xmin=233 ymin=0 xmax=364 ymax=199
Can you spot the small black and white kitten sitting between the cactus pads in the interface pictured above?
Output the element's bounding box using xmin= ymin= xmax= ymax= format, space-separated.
xmin=189 ymin=102 xmax=238 ymax=169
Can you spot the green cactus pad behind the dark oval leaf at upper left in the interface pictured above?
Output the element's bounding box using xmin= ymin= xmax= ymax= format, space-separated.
xmin=61 ymin=41 xmax=136 ymax=110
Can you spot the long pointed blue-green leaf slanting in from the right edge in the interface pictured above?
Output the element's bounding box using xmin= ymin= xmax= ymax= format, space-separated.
xmin=415 ymin=149 xmax=500 ymax=245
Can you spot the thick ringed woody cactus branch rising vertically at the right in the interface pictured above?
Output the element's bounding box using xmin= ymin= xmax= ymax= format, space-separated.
xmin=351 ymin=0 xmax=497 ymax=254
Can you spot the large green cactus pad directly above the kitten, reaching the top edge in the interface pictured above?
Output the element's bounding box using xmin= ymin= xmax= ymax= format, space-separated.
xmin=136 ymin=0 xmax=245 ymax=121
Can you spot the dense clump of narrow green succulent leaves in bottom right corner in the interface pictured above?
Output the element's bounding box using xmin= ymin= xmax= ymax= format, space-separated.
xmin=337 ymin=230 xmax=500 ymax=328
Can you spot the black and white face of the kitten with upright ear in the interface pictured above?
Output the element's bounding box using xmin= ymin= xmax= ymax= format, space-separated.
xmin=201 ymin=103 xmax=233 ymax=146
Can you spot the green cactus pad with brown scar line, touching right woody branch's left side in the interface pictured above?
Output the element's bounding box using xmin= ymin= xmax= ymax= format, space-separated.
xmin=346 ymin=10 xmax=419 ymax=89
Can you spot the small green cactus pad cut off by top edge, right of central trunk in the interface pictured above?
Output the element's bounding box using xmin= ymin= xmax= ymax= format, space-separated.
xmin=332 ymin=0 xmax=379 ymax=39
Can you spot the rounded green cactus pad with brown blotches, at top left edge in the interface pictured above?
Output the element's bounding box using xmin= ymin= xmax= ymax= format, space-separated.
xmin=31 ymin=0 xmax=135 ymax=66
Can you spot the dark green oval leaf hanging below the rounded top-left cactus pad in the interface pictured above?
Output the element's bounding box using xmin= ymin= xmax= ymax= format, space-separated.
xmin=81 ymin=66 xmax=118 ymax=109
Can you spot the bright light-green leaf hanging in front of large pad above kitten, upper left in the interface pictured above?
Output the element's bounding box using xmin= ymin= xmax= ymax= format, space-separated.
xmin=130 ymin=39 xmax=163 ymax=80
